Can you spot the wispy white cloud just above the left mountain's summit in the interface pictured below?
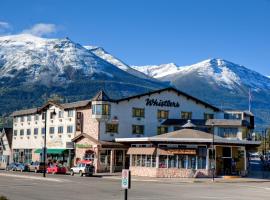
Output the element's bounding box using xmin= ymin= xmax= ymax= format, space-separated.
xmin=22 ymin=23 xmax=57 ymax=36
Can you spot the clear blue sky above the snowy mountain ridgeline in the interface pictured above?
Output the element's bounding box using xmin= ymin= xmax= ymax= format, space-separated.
xmin=0 ymin=0 xmax=270 ymax=75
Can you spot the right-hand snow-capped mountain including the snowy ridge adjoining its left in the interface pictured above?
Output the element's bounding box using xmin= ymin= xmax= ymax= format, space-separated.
xmin=135 ymin=59 xmax=270 ymax=126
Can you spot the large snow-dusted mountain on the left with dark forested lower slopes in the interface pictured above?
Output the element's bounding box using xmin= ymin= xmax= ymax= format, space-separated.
xmin=0 ymin=34 xmax=164 ymax=114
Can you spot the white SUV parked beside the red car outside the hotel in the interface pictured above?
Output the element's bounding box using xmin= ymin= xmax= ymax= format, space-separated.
xmin=70 ymin=161 xmax=95 ymax=176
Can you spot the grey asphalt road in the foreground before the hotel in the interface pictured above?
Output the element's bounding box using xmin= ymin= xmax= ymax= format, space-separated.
xmin=0 ymin=171 xmax=270 ymax=200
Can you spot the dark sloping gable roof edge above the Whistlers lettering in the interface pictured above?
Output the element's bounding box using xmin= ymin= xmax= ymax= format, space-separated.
xmin=115 ymin=87 xmax=220 ymax=111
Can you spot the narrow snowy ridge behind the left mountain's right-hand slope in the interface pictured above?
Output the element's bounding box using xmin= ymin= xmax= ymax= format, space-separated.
xmin=84 ymin=45 xmax=154 ymax=80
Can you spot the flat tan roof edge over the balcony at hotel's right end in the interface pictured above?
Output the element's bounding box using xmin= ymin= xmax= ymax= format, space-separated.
xmin=205 ymin=119 xmax=249 ymax=126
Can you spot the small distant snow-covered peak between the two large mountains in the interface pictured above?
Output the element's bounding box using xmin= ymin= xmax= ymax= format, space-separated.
xmin=131 ymin=63 xmax=178 ymax=78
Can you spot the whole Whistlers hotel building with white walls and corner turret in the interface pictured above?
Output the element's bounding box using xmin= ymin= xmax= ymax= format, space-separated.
xmin=12 ymin=88 xmax=258 ymax=177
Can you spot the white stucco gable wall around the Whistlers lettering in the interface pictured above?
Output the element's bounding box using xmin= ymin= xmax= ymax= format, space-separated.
xmin=100 ymin=91 xmax=224 ymax=140
